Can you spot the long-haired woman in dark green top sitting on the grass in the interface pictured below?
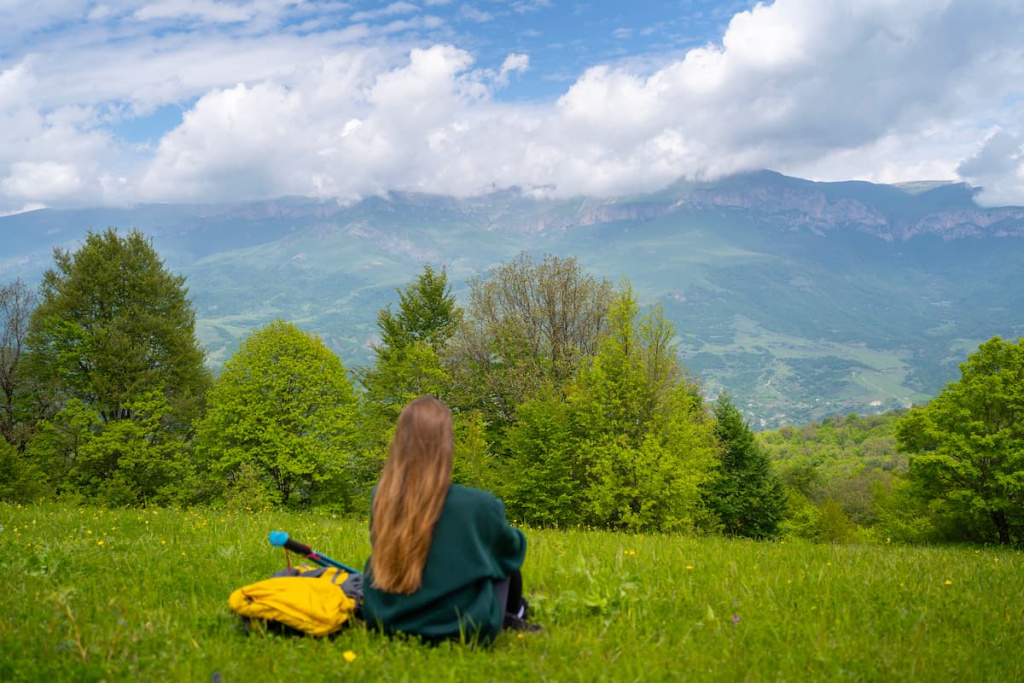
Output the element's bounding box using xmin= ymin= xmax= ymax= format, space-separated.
xmin=362 ymin=396 xmax=536 ymax=642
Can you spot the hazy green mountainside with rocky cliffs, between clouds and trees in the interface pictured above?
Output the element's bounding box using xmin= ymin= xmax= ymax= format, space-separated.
xmin=0 ymin=171 xmax=1024 ymax=427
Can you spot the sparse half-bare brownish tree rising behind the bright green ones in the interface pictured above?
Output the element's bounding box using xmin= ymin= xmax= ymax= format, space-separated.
xmin=445 ymin=252 xmax=612 ymax=437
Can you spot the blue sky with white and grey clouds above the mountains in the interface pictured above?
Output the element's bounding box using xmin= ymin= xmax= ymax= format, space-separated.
xmin=0 ymin=0 xmax=1024 ymax=213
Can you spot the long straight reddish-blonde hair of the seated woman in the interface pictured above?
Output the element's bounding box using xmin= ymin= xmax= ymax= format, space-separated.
xmin=370 ymin=396 xmax=454 ymax=595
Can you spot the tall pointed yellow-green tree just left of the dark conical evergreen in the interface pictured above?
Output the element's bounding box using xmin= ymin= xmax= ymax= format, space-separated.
xmin=568 ymin=283 xmax=716 ymax=530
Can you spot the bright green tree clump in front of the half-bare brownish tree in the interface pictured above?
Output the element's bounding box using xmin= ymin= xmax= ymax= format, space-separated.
xmin=503 ymin=283 xmax=715 ymax=530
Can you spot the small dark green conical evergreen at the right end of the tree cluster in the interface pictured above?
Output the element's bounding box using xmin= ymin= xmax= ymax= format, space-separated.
xmin=708 ymin=393 xmax=786 ymax=539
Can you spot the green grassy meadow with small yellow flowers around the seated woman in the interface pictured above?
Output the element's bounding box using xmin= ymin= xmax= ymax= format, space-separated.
xmin=0 ymin=504 xmax=1024 ymax=683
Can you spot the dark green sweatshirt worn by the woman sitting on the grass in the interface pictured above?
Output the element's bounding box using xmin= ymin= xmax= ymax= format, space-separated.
xmin=362 ymin=484 xmax=526 ymax=641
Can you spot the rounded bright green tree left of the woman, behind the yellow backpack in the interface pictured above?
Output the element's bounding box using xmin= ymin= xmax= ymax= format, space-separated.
xmin=196 ymin=321 xmax=356 ymax=509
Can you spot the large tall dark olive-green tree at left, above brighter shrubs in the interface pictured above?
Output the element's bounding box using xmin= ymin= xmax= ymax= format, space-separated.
xmin=24 ymin=228 xmax=210 ymax=430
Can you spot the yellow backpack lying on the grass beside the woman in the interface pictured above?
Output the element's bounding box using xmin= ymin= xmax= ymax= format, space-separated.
xmin=227 ymin=566 xmax=362 ymax=636
